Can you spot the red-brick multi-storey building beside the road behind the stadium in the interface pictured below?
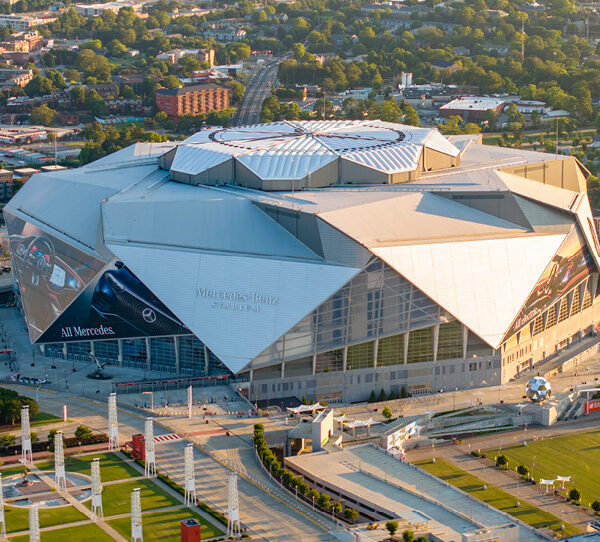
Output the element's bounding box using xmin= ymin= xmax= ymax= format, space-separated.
xmin=155 ymin=83 xmax=229 ymax=122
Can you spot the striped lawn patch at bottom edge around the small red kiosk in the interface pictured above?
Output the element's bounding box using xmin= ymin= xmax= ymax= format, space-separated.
xmin=108 ymin=508 xmax=225 ymax=542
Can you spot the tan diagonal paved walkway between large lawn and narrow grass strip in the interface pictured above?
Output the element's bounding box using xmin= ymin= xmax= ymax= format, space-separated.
xmin=420 ymin=446 xmax=597 ymax=532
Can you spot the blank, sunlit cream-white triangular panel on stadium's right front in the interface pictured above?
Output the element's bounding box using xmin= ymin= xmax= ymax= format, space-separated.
xmin=371 ymin=234 xmax=566 ymax=348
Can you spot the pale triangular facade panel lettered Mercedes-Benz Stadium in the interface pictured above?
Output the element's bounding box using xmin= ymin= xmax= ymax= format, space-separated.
xmin=107 ymin=243 xmax=360 ymax=372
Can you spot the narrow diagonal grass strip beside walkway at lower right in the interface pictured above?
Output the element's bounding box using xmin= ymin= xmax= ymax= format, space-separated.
xmin=415 ymin=459 xmax=581 ymax=536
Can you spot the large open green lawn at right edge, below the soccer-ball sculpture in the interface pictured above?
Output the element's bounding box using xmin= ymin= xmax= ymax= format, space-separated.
xmin=486 ymin=431 xmax=600 ymax=505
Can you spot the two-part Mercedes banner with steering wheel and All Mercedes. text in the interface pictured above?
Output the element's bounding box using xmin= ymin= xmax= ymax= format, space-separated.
xmin=6 ymin=214 xmax=190 ymax=343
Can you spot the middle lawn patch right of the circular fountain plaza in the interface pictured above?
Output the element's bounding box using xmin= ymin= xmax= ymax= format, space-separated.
xmin=84 ymin=479 xmax=183 ymax=517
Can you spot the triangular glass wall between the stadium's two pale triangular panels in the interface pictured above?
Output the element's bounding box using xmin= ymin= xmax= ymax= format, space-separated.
xmin=255 ymin=259 xmax=453 ymax=367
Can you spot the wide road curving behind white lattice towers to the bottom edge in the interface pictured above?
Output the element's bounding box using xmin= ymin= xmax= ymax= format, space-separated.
xmin=7 ymin=386 xmax=334 ymax=541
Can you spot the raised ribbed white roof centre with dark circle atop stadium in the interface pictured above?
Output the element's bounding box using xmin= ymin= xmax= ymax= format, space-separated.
xmin=166 ymin=120 xmax=459 ymax=180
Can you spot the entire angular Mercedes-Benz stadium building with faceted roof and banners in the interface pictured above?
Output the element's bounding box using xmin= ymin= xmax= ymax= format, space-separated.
xmin=4 ymin=121 xmax=600 ymax=403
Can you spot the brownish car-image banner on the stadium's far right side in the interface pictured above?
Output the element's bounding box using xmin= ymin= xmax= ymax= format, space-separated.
xmin=506 ymin=227 xmax=595 ymax=337
